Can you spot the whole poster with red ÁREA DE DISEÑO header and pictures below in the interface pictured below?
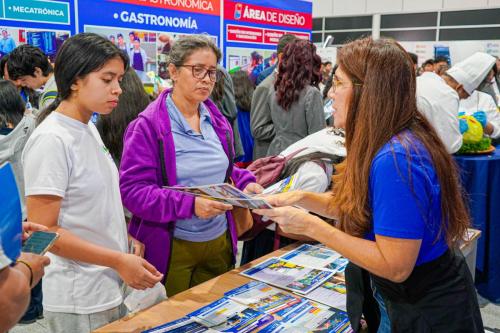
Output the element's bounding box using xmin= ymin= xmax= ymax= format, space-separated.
xmin=223 ymin=0 xmax=312 ymax=81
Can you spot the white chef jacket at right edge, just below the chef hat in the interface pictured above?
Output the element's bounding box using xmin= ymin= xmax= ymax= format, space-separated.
xmin=459 ymin=90 xmax=500 ymax=139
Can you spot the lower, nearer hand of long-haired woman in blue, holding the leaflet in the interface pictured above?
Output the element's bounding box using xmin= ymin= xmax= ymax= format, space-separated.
xmin=252 ymin=206 xmax=320 ymax=238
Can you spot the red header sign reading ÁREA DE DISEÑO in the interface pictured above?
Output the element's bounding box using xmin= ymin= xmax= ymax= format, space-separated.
xmin=224 ymin=1 xmax=312 ymax=29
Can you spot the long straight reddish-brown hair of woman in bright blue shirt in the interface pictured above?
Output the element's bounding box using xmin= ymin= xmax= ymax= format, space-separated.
xmin=332 ymin=38 xmax=469 ymax=246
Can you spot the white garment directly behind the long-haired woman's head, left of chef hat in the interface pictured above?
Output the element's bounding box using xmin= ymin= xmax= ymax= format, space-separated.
xmin=417 ymin=72 xmax=462 ymax=154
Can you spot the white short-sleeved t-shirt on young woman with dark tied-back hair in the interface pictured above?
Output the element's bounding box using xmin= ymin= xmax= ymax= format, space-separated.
xmin=22 ymin=112 xmax=127 ymax=314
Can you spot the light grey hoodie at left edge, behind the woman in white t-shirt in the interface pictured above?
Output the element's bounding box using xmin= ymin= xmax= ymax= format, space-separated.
xmin=0 ymin=114 xmax=36 ymax=220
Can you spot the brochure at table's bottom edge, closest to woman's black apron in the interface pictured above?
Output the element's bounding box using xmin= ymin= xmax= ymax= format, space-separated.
xmin=260 ymin=300 xmax=351 ymax=333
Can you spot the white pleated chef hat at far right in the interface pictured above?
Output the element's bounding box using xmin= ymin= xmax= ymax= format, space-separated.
xmin=446 ymin=52 xmax=495 ymax=95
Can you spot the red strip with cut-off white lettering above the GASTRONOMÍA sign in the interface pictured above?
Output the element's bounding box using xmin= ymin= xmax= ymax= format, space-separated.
xmin=110 ymin=0 xmax=221 ymax=15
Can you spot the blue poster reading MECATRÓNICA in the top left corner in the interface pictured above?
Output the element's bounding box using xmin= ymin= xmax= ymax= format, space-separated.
xmin=0 ymin=0 xmax=76 ymax=61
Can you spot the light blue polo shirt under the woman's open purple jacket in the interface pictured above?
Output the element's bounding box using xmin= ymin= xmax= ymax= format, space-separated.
xmin=166 ymin=94 xmax=229 ymax=242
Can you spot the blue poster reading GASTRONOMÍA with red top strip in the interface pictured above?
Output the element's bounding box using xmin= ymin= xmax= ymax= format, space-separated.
xmin=78 ymin=0 xmax=222 ymax=82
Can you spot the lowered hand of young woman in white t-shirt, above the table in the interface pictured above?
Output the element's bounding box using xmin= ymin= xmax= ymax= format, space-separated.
xmin=115 ymin=253 xmax=163 ymax=290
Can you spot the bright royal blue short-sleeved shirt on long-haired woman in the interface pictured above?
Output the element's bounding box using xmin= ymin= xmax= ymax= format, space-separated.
xmin=366 ymin=131 xmax=448 ymax=266
